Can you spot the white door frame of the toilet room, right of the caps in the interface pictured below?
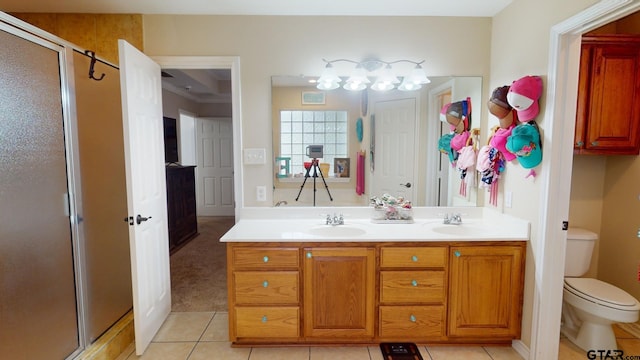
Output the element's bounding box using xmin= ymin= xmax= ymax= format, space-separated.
xmin=528 ymin=0 xmax=640 ymax=359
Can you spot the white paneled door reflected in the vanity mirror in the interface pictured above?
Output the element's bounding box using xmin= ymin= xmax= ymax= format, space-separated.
xmin=372 ymin=98 xmax=416 ymax=201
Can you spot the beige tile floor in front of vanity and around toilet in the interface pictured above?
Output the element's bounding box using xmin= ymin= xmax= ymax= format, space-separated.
xmin=117 ymin=312 xmax=640 ymax=360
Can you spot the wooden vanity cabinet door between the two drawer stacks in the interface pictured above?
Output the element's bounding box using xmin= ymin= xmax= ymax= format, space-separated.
xmin=304 ymin=248 xmax=375 ymax=341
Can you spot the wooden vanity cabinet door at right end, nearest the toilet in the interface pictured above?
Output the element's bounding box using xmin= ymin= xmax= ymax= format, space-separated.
xmin=449 ymin=245 xmax=524 ymax=338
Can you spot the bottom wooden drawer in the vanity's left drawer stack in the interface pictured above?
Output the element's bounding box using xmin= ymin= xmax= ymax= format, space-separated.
xmin=235 ymin=307 xmax=300 ymax=338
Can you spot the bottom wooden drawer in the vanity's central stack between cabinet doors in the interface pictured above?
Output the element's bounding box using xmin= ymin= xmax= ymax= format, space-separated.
xmin=380 ymin=305 xmax=445 ymax=339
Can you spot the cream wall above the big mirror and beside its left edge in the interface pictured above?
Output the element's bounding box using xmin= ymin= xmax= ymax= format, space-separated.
xmin=144 ymin=15 xmax=491 ymax=206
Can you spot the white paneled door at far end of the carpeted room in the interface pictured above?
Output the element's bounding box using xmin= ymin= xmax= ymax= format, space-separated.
xmin=196 ymin=118 xmax=235 ymax=216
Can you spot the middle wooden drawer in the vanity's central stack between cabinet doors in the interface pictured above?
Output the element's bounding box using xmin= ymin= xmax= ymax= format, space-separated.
xmin=380 ymin=270 xmax=445 ymax=303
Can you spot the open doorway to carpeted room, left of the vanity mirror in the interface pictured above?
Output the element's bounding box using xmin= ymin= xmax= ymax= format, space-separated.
xmin=152 ymin=57 xmax=242 ymax=311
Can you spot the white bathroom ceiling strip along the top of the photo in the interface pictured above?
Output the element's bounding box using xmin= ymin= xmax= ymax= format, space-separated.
xmin=1 ymin=0 xmax=512 ymax=17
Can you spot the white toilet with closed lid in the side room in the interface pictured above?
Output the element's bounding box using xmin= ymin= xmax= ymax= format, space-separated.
xmin=560 ymin=228 xmax=640 ymax=351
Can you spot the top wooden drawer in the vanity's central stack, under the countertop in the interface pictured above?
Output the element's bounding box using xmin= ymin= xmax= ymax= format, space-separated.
xmin=380 ymin=246 xmax=447 ymax=268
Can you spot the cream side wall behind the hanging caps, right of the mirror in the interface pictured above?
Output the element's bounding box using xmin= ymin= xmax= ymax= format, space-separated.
xmin=490 ymin=0 xmax=597 ymax=345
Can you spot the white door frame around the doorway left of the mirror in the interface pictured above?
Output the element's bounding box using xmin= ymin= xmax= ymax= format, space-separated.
xmin=150 ymin=56 xmax=244 ymax=220
